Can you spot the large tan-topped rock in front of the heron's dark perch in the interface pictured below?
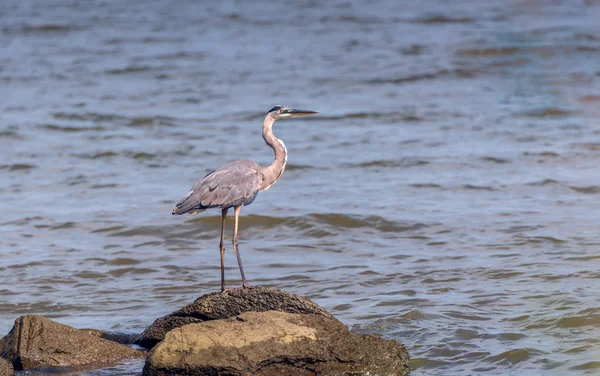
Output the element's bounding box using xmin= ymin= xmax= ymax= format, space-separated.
xmin=142 ymin=311 xmax=409 ymax=376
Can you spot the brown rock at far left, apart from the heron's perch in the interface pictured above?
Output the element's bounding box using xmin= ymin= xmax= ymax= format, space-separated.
xmin=0 ymin=315 xmax=145 ymax=370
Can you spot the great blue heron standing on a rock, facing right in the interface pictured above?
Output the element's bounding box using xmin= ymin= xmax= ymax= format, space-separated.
xmin=172 ymin=106 xmax=317 ymax=291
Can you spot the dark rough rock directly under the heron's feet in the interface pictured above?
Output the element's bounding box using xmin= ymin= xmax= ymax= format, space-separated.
xmin=135 ymin=287 xmax=335 ymax=349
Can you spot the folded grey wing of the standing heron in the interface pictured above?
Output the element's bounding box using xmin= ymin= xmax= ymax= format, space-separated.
xmin=173 ymin=161 xmax=262 ymax=214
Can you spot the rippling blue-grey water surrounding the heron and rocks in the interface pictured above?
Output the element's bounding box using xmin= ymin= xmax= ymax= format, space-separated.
xmin=0 ymin=0 xmax=600 ymax=375
